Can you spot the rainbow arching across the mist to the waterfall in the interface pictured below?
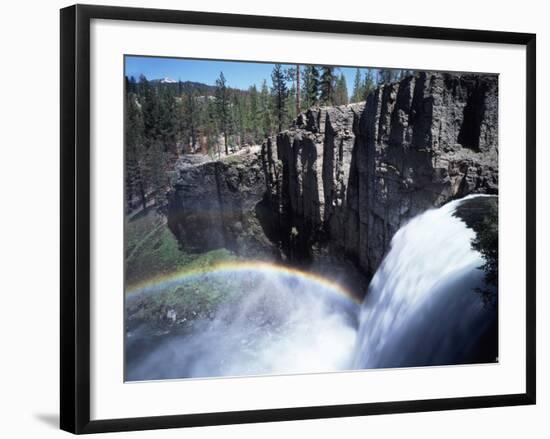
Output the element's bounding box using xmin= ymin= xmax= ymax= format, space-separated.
xmin=126 ymin=260 xmax=360 ymax=304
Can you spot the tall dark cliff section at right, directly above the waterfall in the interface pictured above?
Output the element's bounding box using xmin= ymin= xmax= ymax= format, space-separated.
xmin=357 ymin=73 xmax=498 ymax=273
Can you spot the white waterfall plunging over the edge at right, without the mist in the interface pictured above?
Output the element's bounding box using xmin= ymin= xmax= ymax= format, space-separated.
xmin=352 ymin=196 xmax=497 ymax=369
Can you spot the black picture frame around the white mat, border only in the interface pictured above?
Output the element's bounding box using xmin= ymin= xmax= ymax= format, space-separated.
xmin=60 ymin=5 xmax=536 ymax=434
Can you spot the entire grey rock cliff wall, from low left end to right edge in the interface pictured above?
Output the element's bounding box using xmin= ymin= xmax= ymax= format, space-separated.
xmin=168 ymin=73 xmax=498 ymax=275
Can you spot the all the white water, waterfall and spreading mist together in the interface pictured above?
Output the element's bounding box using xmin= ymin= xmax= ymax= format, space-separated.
xmin=126 ymin=196 xmax=498 ymax=380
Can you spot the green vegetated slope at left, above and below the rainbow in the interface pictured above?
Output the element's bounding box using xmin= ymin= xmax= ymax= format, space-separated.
xmin=125 ymin=207 xmax=246 ymax=329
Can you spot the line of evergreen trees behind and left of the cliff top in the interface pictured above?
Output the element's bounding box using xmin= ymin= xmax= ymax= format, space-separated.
xmin=125 ymin=64 xmax=416 ymax=210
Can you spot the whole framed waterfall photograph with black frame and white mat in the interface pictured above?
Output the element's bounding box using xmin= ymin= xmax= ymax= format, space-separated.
xmin=61 ymin=5 xmax=536 ymax=433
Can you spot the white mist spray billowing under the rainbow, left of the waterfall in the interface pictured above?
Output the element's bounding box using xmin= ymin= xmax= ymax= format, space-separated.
xmin=127 ymin=271 xmax=359 ymax=380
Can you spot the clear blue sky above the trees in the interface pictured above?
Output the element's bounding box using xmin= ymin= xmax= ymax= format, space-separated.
xmin=125 ymin=56 xmax=378 ymax=94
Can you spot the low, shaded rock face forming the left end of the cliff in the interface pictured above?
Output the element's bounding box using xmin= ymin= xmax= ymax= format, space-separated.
xmin=167 ymin=153 xmax=277 ymax=255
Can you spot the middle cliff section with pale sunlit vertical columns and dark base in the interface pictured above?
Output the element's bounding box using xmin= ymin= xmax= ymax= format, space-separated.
xmin=277 ymin=104 xmax=364 ymax=259
